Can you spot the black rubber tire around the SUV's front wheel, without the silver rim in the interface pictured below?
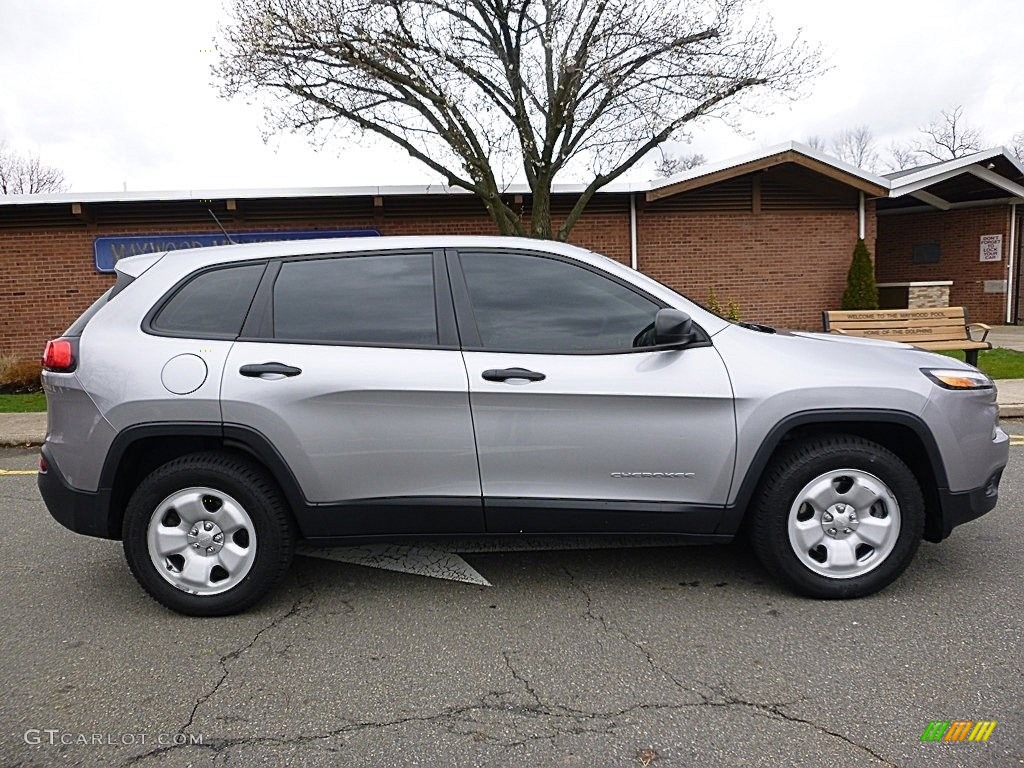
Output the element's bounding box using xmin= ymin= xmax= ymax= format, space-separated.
xmin=749 ymin=435 xmax=925 ymax=599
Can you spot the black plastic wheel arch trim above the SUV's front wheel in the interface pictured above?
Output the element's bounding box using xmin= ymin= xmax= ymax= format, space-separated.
xmin=716 ymin=409 xmax=949 ymax=534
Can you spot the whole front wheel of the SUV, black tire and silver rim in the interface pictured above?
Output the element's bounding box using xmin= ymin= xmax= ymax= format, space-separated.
xmin=750 ymin=435 xmax=925 ymax=598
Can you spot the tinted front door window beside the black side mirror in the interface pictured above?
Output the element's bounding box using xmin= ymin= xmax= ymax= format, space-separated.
xmin=459 ymin=252 xmax=660 ymax=352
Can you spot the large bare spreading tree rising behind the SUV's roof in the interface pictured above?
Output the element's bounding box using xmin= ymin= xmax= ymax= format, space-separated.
xmin=214 ymin=0 xmax=820 ymax=240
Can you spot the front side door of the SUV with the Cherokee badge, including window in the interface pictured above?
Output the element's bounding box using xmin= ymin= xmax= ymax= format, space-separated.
xmin=449 ymin=249 xmax=735 ymax=534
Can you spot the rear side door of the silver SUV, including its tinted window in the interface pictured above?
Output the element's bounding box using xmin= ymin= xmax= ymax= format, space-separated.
xmin=221 ymin=251 xmax=483 ymax=536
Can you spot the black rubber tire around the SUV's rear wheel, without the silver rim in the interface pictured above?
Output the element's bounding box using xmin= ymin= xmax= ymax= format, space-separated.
xmin=122 ymin=452 xmax=296 ymax=616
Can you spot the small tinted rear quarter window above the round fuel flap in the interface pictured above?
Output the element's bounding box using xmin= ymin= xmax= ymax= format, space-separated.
xmin=153 ymin=264 xmax=264 ymax=338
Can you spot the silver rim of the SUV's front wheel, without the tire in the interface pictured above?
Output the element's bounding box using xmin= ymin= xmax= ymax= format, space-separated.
xmin=787 ymin=469 xmax=900 ymax=579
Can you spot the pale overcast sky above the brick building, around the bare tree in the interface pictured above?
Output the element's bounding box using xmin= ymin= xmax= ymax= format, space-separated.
xmin=0 ymin=0 xmax=1024 ymax=191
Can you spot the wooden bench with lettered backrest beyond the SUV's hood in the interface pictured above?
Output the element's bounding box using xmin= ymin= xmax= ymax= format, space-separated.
xmin=821 ymin=306 xmax=992 ymax=366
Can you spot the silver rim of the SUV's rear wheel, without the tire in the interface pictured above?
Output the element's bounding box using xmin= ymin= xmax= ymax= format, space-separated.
xmin=146 ymin=487 xmax=256 ymax=596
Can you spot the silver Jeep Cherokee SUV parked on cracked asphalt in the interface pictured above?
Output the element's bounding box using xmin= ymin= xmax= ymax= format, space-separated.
xmin=39 ymin=237 xmax=1009 ymax=615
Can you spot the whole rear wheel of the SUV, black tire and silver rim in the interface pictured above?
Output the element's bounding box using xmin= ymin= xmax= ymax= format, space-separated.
xmin=123 ymin=453 xmax=295 ymax=615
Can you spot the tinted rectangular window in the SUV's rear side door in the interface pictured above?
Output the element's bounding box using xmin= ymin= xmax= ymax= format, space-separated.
xmin=273 ymin=253 xmax=437 ymax=345
